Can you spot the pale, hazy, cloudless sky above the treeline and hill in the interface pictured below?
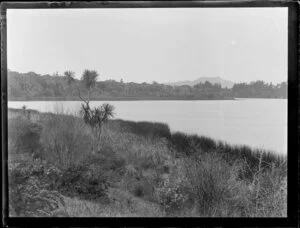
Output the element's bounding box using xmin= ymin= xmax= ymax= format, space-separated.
xmin=7 ymin=8 xmax=288 ymax=83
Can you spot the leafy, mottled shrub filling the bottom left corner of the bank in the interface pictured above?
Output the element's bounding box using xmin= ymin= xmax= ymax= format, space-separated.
xmin=8 ymin=156 xmax=66 ymax=216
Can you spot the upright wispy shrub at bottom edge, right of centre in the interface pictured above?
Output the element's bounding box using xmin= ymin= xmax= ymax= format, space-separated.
xmin=184 ymin=153 xmax=231 ymax=216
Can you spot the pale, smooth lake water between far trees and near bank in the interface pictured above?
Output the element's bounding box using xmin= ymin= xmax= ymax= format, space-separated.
xmin=8 ymin=99 xmax=287 ymax=154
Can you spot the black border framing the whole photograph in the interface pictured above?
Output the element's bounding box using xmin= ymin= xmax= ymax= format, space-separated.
xmin=0 ymin=0 xmax=300 ymax=227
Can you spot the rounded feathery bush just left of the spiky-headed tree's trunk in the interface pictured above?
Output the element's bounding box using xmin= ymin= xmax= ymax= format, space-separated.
xmin=41 ymin=114 xmax=92 ymax=168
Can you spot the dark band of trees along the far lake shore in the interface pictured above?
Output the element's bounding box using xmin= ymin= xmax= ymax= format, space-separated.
xmin=8 ymin=71 xmax=287 ymax=100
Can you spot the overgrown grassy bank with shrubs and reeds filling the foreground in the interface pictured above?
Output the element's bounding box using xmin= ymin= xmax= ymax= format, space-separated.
xmin=8 ymin=110 xmax=287 ymax=217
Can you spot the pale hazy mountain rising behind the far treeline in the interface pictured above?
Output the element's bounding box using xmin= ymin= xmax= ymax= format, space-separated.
xmin=165 ymin=77 xmax=234 ymax=89
